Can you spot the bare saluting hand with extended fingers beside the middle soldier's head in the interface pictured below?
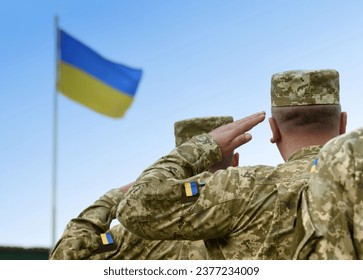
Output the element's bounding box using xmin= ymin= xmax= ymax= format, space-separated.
xmin=209 ymin=112 xmax=266 ymax=158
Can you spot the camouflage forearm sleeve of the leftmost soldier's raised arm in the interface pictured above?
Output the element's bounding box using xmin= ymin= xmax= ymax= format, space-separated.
xmin=50 ymin=188 xmax=124 ymax=260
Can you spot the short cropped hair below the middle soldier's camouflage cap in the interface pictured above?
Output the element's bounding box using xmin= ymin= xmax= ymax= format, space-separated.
xmin=271 ymin=104 xmax=341 ymax=133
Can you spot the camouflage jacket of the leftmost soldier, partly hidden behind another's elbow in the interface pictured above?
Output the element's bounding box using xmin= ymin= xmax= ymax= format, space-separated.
xmin=50 ymin=189 xmax=206 ymax=260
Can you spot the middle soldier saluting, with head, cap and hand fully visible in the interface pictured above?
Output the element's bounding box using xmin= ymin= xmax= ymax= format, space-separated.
xmin=117 ymin=70 xmax=346 ymax=259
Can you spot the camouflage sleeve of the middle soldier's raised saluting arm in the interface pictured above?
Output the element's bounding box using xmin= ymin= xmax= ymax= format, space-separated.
xmin=117 ymin=134 xmax=262 ymax=240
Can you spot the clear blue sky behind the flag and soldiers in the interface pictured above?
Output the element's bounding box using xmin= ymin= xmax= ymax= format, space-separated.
xmin=0 ymin=0 xmax=363 ymax=247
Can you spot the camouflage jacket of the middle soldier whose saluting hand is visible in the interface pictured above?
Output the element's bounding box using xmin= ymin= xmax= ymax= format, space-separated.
xmin=117 ymin=134 xmax=320 ymax=259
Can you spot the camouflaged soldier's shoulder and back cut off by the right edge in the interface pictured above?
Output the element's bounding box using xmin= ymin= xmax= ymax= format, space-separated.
xmin=296 ymin=128 xmax=363 ymax=260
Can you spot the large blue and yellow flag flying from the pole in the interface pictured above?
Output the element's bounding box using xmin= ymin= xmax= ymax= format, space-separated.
xmin=57 ymin=29 xmax=142 ymax=118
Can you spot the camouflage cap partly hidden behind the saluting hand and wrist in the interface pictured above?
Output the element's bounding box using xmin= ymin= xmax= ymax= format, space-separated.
xmin=174 ymin=116 xmax=233 ymax=147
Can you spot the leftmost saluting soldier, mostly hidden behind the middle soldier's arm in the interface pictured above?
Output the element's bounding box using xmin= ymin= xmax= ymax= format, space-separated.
xmin=50 ymin=117 xmax=238 ymax=260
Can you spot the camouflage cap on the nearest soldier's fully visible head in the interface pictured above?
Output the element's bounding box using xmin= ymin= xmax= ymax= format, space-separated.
xmin=271 ymin=69 xmax=339 ymax=107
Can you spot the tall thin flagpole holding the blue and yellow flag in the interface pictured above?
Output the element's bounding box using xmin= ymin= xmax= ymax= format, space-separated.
xmin=50 ymin=16 xmax=59 ymax=251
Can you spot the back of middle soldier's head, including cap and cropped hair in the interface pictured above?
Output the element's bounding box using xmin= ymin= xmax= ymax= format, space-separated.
xmin=271 ymin=69 xmax=341 ymax=135
